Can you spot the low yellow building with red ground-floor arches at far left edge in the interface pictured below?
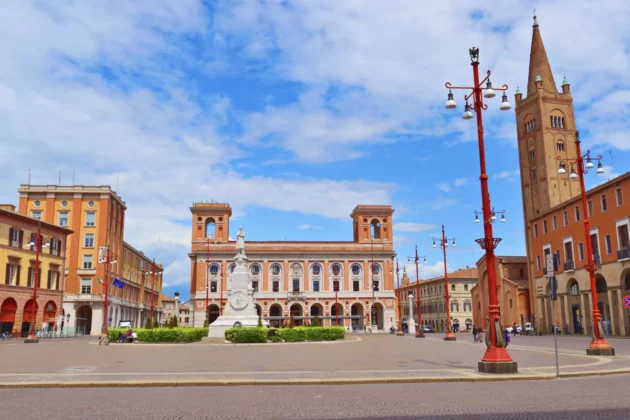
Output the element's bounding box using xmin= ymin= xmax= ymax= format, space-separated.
xmin=0 ymin=204 xmax=71 ymax=337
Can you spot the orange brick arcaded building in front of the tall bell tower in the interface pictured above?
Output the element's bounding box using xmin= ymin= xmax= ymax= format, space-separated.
xmin=529 ymin=172 xmax=630 ymax=336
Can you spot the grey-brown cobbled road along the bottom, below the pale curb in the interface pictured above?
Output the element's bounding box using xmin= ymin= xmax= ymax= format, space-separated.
xmin=0 ymin=375 xmax=630 ymax=420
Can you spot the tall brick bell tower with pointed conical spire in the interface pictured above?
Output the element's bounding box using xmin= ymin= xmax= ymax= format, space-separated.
xmin=515 ymin=16 xmax=580 ymax=319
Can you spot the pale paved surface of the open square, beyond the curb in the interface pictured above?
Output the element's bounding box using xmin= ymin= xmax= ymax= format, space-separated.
xmin=0 ymin=334 xmax=630 ymax=385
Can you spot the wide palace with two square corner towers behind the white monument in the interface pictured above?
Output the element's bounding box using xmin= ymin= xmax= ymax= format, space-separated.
xmin=189 ymin=203 xmax=396 ymax=330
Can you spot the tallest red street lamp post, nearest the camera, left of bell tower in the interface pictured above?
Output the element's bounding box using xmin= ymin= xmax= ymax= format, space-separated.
xmin=445 ymin=47 xmax=518 ymax=373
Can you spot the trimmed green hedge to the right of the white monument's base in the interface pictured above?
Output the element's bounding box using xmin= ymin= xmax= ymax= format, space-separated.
xmin=225 ymin=327 xmax=346 ymax=343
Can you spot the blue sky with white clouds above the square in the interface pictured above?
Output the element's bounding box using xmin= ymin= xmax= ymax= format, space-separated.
xmin=0 ymin=0 xmax=630 ymax=297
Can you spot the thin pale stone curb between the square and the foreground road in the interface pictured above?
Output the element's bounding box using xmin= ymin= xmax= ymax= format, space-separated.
xmin=0 ymin=368 xmax=630 ymax=389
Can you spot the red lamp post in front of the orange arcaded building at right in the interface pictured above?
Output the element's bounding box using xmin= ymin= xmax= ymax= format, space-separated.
xmin=557 ymin=131 xmax=615 ymax=356
